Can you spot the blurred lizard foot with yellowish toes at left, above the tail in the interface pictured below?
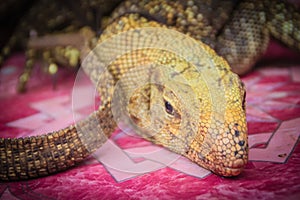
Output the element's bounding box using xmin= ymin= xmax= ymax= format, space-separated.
xmin=18 ymin=27 xmax=95 ymax=92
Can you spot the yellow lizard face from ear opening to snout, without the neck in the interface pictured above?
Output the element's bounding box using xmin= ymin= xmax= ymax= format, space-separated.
xmin=128 ymin=48 xmax=248 ymax=176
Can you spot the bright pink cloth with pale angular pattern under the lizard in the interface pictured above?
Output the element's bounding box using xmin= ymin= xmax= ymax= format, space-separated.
xmin=0 ymin=43 xmax=300 ymax=200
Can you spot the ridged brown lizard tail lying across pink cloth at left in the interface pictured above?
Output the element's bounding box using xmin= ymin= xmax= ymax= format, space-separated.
xmin=0 ymin=106 xmax=115 ymax=181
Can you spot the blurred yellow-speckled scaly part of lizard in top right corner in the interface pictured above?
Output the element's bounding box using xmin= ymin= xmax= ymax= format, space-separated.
xmin=265 ymin=0 xmax=300 ymax=51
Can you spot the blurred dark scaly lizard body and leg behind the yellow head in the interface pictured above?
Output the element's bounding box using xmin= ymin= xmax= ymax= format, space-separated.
xmin=112 ymin=0 xmax=300 ymax=75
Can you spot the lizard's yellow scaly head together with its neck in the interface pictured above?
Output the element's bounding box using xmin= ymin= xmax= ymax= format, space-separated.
xmin=87 ymin=27 xmax=248 ymax=176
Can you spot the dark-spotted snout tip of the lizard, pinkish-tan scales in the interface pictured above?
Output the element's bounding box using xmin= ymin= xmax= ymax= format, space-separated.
xmin=186 ymin=119 xmax=248 ymax=177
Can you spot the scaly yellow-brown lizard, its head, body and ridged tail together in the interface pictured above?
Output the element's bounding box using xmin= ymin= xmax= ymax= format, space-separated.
xmin=0 ymin=0 xmax=299 ymax=180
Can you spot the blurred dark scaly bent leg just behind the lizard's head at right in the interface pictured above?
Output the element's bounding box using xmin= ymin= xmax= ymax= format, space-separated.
xmin=215 ymin=0 xmax=269 ymax=74
